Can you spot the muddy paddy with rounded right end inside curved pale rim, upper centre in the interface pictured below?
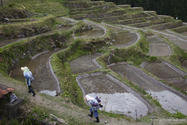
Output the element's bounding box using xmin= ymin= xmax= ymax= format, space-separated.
xmin=111 ymin=32 xmax=138 ymax=47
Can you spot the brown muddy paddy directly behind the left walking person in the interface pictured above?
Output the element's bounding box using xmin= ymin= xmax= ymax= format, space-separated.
xmin=11 ymin=48 xmax=61 ymax=96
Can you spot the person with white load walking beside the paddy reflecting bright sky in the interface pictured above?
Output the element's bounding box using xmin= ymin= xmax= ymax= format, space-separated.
xmin=84 ymin=95 xmax=103 ymax=123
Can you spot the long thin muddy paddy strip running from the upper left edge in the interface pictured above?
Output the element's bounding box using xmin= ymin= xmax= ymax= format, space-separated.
xmin=0 ymin=26 xmax=73 ymax=47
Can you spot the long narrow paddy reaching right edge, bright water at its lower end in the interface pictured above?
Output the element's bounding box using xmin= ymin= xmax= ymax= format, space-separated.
xmin=110 ymin=64 xmax=187 ymax=114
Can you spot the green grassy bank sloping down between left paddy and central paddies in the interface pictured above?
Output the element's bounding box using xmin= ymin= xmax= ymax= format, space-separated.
xmin=51 ymin=52 xmax=84 ymax=105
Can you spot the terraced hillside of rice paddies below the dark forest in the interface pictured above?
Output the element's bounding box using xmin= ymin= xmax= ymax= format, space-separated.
xmin=0 ymin=0 xmax=187 ymax=125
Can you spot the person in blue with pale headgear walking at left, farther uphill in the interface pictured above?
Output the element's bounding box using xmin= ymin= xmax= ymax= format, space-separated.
xmin=21 ymin=66 xmax=36 ymax=96
